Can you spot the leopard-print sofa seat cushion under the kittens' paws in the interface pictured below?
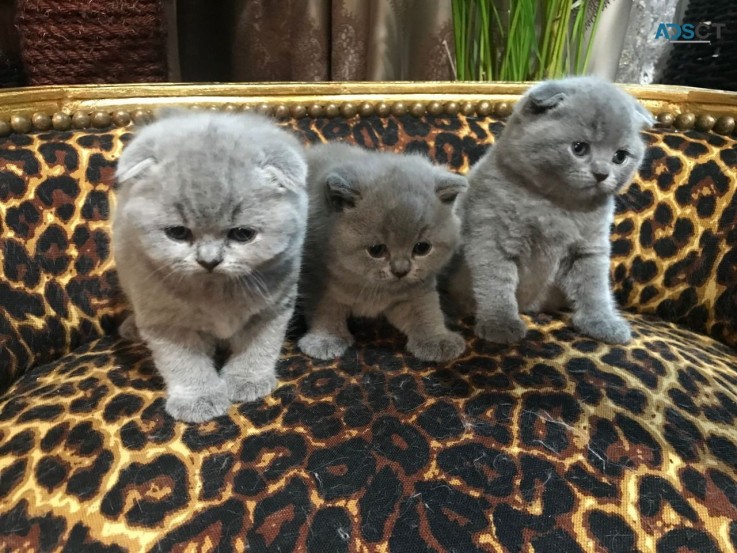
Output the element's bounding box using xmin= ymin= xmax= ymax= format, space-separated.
xmin=0 ymin=314 xmax=737 ymax=553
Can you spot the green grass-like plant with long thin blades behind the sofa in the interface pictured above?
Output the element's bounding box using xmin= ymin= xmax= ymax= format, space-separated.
xmin=452 ymin=0 xmax=608 ymax=81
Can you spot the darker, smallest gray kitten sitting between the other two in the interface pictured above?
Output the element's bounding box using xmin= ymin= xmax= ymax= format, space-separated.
xmin=299 ymin=143 xmax=468 ymax=361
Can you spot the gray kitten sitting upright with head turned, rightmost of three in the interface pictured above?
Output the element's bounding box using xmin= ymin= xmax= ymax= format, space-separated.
xmin=450 ymin=77 xmax=653 ymax=344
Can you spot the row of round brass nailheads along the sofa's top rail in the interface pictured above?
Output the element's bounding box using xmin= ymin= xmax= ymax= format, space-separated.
xmin=0 ymin=100 xmax=737 ymax=136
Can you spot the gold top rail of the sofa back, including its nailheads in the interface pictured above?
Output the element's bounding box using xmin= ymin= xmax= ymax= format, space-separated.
xmin=0 ymin=82 xmax=737 ymax=135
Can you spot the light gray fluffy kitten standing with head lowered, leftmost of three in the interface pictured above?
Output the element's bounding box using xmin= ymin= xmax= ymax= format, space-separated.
xmin=113 ymin=112 xmax=308 ymax=422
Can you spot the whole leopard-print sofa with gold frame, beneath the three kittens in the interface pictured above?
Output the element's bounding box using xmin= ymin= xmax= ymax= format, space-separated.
xmin=0 ymin=83 xmax=737 ymax=553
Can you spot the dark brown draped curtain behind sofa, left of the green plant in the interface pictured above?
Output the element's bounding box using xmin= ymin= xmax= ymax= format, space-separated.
xmin=176 ymin=0 xmax=453 ymax=82
